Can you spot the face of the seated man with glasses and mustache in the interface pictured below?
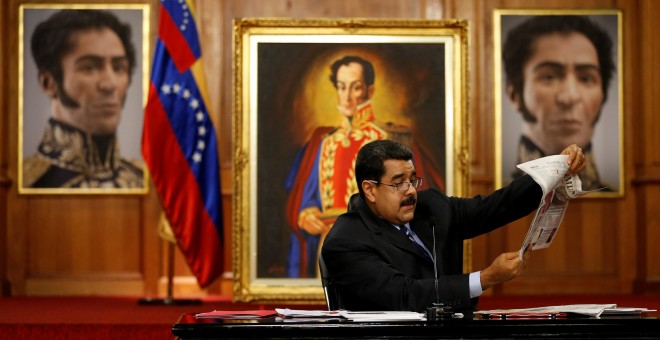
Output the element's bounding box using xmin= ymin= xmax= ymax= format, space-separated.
xmin=363 ymin=159 xmax=417 ymax=225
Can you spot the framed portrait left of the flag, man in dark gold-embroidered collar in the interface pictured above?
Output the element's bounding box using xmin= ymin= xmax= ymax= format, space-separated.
xmin=17 ymin=3 xmax=150 ymax=194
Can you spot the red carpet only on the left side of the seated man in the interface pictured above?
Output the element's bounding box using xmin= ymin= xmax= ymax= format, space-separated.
xmin=0 ymin=297 xmax=325 ymax=339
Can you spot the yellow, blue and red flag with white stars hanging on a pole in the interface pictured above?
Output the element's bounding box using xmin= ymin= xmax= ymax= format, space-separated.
xmin=142 ymin=0 xmax=223 ymax=287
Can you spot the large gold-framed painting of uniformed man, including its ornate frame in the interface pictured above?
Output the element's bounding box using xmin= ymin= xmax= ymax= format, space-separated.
xmin=233 ymin=18 xmax=470 ymax=302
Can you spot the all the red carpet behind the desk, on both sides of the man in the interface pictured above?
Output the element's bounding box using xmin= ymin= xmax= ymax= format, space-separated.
xmin=0 ymin=295 xmax=660 ymax=339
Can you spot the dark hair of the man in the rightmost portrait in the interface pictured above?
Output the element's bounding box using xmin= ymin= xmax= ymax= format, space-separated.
xmin=502 ymin=15 xmax=615 ymax=120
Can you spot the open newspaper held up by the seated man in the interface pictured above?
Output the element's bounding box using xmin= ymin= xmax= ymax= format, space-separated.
xmin=518 ymin=155 xmax=592 ymax=259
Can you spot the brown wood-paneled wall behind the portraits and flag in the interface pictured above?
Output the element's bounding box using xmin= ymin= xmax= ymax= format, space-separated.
xmin=0 ymin=0 xmax=660 ymax=295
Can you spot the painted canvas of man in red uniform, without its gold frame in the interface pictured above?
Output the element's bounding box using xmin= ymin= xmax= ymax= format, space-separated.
xmin=250 ymin=44 xmax=446 ymax=278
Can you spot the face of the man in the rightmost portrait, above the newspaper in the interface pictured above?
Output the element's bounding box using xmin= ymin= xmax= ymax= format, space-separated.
xmin=512 ymin=32 xmax=604 ymax=154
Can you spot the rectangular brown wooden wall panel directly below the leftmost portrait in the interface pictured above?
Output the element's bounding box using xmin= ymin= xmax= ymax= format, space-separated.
xmin=24 ymin=196 xmax=142 ymax=276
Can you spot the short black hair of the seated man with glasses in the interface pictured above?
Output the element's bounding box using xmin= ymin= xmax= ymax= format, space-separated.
xmin=355 ymin=139 xmax=413 ymax=199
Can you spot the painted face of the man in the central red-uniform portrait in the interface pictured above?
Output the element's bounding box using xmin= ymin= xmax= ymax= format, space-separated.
xmin=336 ymin=63 xmax=373 ymax=117
